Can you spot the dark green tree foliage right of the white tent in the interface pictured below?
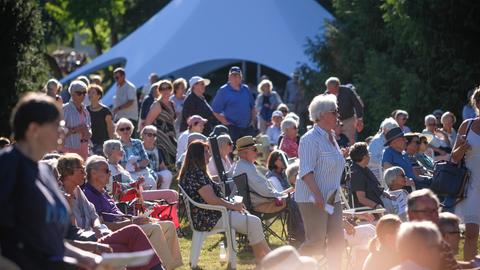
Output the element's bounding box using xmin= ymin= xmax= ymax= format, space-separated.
xmin=302 ymin=0 xmax=480 ymax=135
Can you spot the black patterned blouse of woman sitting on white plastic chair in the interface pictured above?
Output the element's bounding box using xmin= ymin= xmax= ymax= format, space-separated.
xmin=180 ymin=168 xmax=223 ymax=231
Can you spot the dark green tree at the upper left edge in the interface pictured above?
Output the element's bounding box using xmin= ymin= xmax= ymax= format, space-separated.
xmin=0 ymin=0 xmax=48 ymax=135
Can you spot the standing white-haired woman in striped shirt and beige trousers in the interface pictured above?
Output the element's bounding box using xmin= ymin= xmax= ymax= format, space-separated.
xmin=295 ymin=94 xmax=345 ymax=269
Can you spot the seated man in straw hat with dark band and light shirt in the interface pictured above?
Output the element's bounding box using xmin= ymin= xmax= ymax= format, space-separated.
xmin=233 ymin=136 xmax=286 ymax=213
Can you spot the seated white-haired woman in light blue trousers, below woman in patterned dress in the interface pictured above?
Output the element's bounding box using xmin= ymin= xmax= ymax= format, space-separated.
xmin=140 ymin=125 xmax=172 ymax=189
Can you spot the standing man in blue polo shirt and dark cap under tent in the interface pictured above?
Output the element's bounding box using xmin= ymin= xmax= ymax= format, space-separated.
xmin=212 ymin=66 xmax=256 ymax=142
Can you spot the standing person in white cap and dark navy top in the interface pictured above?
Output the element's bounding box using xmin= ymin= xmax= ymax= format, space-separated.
xmin=180 ymin=76 xmax=218 ymax=136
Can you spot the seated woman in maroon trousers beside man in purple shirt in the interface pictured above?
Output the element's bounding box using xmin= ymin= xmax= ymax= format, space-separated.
xmin=57 ymin=153 xmax=163 ymax=269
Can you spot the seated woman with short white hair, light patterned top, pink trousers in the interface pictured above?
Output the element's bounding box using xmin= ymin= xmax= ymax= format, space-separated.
xmin=103 ymin=140 xmax=178 ymax=202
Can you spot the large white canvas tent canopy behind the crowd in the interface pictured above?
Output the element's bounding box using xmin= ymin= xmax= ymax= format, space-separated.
xmin=62 ymin=0 xmax=332 ymax=104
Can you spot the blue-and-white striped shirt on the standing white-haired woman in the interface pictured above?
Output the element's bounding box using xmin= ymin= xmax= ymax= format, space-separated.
xmin=295 ymin=125 xmax=345 ymax=203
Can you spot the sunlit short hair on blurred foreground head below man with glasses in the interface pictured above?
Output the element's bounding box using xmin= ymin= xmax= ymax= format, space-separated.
xmin=397 ymin=221 xmax=442 ymax=259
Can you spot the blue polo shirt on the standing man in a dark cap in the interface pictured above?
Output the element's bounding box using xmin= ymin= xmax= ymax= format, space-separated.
xmin=212 ymin=83 xmax=254 ymax=128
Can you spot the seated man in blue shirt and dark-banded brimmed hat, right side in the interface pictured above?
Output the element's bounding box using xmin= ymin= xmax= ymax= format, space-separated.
xmin=382 ymin=127 xmax=432 ymax=192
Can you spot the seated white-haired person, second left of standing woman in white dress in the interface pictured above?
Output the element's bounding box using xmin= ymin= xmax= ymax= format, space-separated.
xmin=422 ymin=114 xmax=452 ymax=160
